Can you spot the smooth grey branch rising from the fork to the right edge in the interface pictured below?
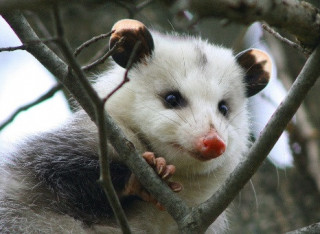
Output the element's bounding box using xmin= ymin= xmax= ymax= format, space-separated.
xmin=182 ymin=43 xmax=320 ymax=233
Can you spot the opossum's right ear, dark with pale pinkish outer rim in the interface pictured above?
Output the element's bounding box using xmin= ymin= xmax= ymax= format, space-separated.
xmin=236 ymin=49 xmax=272 ymax=97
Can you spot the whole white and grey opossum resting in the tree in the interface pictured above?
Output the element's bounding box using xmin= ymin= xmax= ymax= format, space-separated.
xmin=0 ymin=20 xmax=271 ymax=233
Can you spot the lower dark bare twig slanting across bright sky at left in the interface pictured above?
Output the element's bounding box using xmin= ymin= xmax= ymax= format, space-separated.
xmin=0 ymin=84 xmax=62 ymax=131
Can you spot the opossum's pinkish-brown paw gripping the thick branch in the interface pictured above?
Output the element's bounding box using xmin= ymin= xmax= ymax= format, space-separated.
xmin=124 ymin=152 xmax=182 ymax=210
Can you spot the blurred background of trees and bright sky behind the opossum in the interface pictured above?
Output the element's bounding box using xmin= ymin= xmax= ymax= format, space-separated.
xmin=0 ymin=0 xmax=320 ymax=233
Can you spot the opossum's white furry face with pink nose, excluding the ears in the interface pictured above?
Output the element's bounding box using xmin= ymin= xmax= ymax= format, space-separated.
xmin=122 ymin=34 xmax=248 ymax=173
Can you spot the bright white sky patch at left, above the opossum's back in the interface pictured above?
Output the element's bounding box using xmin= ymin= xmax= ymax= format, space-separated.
xmin=0 ymin=17 xmax=70 ymax=151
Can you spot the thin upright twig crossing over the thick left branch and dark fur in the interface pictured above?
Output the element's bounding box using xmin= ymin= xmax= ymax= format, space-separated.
xmin=54 ymin=6 xmax=131 ymax=234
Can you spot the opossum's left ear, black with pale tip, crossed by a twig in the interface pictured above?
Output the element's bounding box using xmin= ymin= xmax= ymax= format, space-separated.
xmin=109 ymin=19 xmax=154 ymax=68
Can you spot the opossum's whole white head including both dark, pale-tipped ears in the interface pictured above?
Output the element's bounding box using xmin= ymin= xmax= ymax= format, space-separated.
xmin=99 ymin=20 xmax=271 ymax=176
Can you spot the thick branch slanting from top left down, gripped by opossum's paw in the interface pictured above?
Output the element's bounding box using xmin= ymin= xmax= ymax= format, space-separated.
xmin=2 ymin=11 xmax=189 ymax=229
